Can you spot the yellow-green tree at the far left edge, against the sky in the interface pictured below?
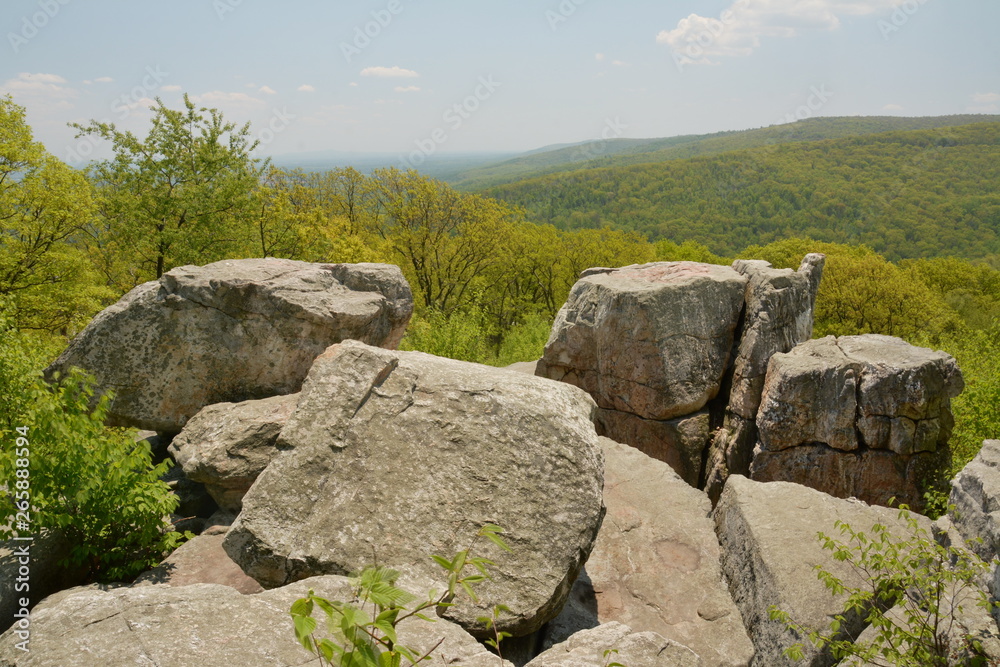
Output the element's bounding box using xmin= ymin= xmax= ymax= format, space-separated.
xmin=0 ymin=96 xmax=108 ymax=333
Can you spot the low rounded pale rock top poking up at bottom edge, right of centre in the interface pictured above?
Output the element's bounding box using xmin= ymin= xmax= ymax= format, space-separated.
xmin=525 ymin=622 xmax=708 ymax=667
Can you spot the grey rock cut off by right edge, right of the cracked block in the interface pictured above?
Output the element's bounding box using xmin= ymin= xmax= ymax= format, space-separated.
xmin=948 ymin=440 xmax=1000 ymax=560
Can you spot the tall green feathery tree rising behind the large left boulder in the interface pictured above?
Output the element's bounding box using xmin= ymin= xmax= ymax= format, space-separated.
xmin=72 ymin=95 xmax=267 ymax=289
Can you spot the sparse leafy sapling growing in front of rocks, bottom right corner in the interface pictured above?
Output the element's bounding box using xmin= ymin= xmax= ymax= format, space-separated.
xmin=769 ymin=506 xmax=993 ymax=667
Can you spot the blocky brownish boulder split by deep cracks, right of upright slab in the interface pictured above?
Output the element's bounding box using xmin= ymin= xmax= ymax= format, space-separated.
xmin=750 ymin=334 xmax=963 ymax=511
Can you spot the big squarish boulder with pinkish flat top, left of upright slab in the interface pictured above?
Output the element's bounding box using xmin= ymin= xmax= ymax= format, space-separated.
xmin=536 ymin=262 xmax=747 ymax=420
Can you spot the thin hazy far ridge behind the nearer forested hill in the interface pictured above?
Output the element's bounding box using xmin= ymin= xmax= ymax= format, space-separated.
xmin=447 ymin=114 xmax=1000 ymax=191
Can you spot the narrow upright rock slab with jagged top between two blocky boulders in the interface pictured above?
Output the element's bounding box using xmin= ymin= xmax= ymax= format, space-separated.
xmin=704 ymin=254 xmax=826 ymax=499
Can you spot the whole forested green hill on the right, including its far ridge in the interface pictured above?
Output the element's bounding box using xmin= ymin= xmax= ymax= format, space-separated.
xmin=481 ymin=121 xmax=1000 ymax=259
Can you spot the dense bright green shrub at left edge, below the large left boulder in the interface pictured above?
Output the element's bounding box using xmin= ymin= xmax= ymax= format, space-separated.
xmin=0 ymin=329 xmax=182 ymax=581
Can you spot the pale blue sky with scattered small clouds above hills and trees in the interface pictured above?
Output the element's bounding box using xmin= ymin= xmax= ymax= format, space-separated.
xmin=0 ymin=0 xmax=1000 ymax=163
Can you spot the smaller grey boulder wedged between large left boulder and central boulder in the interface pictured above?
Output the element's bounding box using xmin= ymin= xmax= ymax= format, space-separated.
xmin=169 ymin=394 xmax=299 ymax=513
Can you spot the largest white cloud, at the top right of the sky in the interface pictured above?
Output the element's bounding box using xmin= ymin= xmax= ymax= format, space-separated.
xmin=656 ymin=0 xmax=900 ymax=65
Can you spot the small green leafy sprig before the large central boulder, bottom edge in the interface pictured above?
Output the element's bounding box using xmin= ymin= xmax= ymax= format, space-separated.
xmin=291 ymin=524 xmax=510 ymax=667
